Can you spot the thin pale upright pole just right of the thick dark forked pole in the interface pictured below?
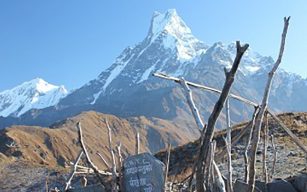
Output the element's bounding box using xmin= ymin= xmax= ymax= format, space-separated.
xmin=225 ymin=99 xmax=233 ymax=192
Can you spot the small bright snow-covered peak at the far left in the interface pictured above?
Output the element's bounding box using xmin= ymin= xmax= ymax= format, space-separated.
xmin=0 ymin=78 xmax=68 ymax=117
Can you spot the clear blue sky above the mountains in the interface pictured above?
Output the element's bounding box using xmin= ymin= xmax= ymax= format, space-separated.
xmin=0 ymin=0 xmax=307 ymax=91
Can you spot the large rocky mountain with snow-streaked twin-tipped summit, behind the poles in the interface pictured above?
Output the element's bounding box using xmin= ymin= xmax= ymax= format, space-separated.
xmin=0 ymin=10 xmax=307 ymax=132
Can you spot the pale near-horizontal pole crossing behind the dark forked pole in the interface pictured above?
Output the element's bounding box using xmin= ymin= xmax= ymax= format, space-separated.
xmin=152 ymin=73 xmax=258 ymax=107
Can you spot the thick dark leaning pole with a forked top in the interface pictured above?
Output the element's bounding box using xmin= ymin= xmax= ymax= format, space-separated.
xmin=196 ymin=41 xmax=248 ymax=192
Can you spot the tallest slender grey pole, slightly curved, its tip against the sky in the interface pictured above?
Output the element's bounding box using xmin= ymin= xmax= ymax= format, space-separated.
xmin=248 ymin=17 xmax=290 ymax=192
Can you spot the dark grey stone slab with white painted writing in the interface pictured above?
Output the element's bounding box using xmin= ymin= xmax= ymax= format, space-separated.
xmin=122 ymin=153 xmax=165 ymax=192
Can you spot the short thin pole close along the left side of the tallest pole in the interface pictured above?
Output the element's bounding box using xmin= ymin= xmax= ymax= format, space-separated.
xmin=244 ymin=107 xmax=259 ymax=183
